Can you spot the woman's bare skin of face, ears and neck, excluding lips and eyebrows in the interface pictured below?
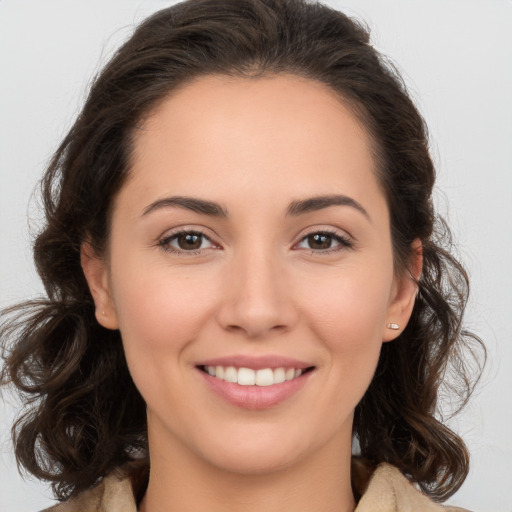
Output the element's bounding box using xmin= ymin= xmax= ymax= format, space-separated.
xmin=82 ymin=75 xmax=421 ymax=512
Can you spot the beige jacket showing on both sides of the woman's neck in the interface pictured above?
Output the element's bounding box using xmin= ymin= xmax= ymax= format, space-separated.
xmin=43 ymin=463 xmax=467 ymax=512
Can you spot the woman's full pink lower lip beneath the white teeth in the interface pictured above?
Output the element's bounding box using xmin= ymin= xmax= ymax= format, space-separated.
xmin=197 ymin=369 xmax=313 ymax=410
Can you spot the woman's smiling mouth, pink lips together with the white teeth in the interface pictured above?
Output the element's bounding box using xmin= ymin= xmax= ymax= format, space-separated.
xmin=196 ymin=356 xmax=315 ymax=410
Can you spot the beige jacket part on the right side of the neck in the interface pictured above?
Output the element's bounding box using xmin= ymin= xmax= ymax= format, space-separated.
xmin=356 ymin=463 xmax=469 ymax=512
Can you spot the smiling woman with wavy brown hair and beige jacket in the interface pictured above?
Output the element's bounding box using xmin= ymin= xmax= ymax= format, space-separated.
xmin=2 ymin=0 xmax=484 ymax=512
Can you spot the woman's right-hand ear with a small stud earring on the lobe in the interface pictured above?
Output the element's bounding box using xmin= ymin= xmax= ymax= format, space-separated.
xmin=382 ymin=239 xmax=423 ymax=341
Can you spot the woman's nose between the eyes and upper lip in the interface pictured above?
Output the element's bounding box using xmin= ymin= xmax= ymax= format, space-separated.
xmin=217 ymin=246 xmax=298 ymax=340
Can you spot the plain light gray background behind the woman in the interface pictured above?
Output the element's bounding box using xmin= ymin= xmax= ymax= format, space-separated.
xmin=0 ymin=0 xmax=512 ymax=512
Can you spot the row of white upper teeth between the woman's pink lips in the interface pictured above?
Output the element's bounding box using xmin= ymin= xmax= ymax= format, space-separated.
xmin=205 ymin=366 xmax=304 ymax=386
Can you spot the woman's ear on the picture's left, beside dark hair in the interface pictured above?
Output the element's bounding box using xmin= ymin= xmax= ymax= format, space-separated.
xmin=80 ymin=242 xmax=119 ymax=329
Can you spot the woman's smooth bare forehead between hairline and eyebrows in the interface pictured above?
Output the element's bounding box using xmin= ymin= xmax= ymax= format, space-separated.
xmin=122 ymin=74 xmax=378 ymax=214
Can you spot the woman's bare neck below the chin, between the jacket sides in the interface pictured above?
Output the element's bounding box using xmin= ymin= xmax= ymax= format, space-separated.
xmin=139 ymin=426 xmax=355 ymax=512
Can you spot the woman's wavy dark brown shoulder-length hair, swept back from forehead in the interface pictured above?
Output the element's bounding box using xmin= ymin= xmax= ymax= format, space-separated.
xmin=1 ymin=0 xmax=480 ymax=500
